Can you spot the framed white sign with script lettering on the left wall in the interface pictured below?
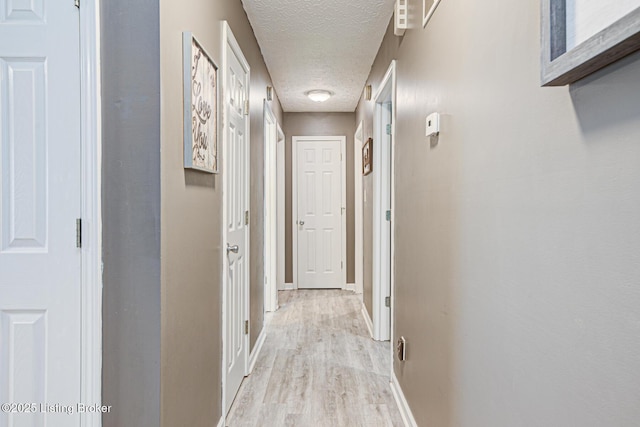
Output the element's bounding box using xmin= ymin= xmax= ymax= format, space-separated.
xmin=182 ymin=31 xmax=220 ymax=173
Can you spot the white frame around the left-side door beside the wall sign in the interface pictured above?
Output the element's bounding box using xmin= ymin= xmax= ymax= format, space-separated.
xmin=218 ymin=21 xmax=251 ymax=419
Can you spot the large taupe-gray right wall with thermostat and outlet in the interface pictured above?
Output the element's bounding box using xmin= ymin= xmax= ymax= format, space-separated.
xmin=357 ymin=0 xmax=640 ymax=427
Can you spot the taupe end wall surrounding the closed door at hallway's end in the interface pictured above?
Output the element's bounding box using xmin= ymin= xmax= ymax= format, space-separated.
xmin=282 ymin=113 xmax=356 ymax=283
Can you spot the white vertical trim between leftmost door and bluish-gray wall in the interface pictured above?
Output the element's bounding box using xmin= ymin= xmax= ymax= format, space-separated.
xmin=79 ymin=0 xmax=102 ymax=427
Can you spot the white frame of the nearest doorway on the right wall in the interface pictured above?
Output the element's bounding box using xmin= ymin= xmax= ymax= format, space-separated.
xmin=373 ymin=60 xmax=396 ymax=347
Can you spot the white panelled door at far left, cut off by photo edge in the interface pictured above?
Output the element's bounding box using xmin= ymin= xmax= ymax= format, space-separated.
xmin=0 ymin=0 xmax=81 ymax=427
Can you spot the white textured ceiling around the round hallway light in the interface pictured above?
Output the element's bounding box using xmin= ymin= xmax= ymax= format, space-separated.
xmin=242 ymin=0 xmax=394 ymax=112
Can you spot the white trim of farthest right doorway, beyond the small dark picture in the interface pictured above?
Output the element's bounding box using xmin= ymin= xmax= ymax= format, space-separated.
xmin=353 ymin=121 xmax=364 ymax=294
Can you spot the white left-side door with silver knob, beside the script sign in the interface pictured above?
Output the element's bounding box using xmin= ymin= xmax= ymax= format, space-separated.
xmin=223 ymin=23 xmax=249 ymax=413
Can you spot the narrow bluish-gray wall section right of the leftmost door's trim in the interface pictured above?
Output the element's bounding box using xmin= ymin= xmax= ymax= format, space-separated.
xmin=100 ymin=0 xmax=161 ymax=427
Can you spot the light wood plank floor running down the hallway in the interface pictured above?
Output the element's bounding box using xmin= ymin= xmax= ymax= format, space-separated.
xmin=226 ymin=290 xmax=403 ymax=427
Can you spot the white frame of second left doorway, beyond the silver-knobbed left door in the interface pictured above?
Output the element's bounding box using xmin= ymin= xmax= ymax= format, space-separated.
xmin=263 ymin=99 xmax=278 ymax=312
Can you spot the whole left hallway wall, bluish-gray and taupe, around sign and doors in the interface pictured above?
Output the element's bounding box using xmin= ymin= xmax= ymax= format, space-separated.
xmin=102 ymin=0 xmax=282 ymax=427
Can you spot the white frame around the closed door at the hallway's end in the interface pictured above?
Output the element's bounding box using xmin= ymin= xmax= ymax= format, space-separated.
xmin=291 ymin=135 xmax=347 ymax=289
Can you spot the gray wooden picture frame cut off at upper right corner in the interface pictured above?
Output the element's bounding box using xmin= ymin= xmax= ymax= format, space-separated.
xmin=540 ymin=0 xmax=640 ymax=86
